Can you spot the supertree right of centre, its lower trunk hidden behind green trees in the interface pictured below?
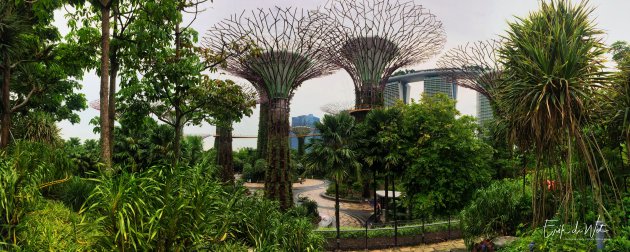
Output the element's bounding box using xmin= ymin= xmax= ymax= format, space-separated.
xmin=318 ymin=0 xmax=446 ymax=116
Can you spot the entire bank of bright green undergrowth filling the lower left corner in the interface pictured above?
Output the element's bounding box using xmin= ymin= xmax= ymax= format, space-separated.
xmin=0 ymin=143 xmax=323 ymax=251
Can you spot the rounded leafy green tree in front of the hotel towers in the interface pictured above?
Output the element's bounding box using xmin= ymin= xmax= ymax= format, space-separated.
xmin=402 ymin=95 xmax=492 ymax=215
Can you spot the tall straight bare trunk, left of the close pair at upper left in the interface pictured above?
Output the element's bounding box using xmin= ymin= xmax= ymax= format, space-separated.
xmin=100 ymin=0 xmax=112 ymax=169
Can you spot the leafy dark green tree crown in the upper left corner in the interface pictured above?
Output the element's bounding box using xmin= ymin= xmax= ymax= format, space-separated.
xmin=0 ymin=0 xmax=87 ymax=123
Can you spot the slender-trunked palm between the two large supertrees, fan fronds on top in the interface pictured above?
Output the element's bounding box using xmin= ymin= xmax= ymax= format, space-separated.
xmin=306 ymin=113 xmax=360 ymax=249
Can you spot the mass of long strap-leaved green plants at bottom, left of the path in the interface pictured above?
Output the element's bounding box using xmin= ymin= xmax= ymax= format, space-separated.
xmin=79 ymin=166 xmax=322 ymax=251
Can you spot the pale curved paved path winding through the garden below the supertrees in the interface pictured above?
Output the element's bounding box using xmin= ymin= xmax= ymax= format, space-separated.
xmin=244 ymin=179 xmax=372 ymax=227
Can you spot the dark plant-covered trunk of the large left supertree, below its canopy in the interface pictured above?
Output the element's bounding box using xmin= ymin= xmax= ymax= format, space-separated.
xmin=265 ymin=98 xmax=293 ymax=210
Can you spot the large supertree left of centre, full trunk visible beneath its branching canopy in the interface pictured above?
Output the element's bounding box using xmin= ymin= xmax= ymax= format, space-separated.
xmin=204 ymin=7 xmax=337 ymax=209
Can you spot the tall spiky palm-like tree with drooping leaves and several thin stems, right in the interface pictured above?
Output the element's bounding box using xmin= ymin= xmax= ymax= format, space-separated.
xmin=498 ymin=0 xmax=607 ymax=225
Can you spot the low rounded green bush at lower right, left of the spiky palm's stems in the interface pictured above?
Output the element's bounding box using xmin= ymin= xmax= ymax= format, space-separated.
xmin=460 ymin=179 xmax=532 ymax=247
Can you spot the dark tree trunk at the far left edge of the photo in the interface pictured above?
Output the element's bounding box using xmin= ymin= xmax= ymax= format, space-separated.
xmin=0 ymin=55 xmax=11 ymax=149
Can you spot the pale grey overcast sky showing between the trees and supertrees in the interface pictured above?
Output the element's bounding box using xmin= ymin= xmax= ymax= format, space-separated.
xmin=55 ymin=0 xmax=630 ymax=148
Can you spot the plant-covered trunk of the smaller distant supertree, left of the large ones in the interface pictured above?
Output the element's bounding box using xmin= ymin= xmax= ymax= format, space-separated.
xmin=215 ymin=126 xmax=234 ymax=183
